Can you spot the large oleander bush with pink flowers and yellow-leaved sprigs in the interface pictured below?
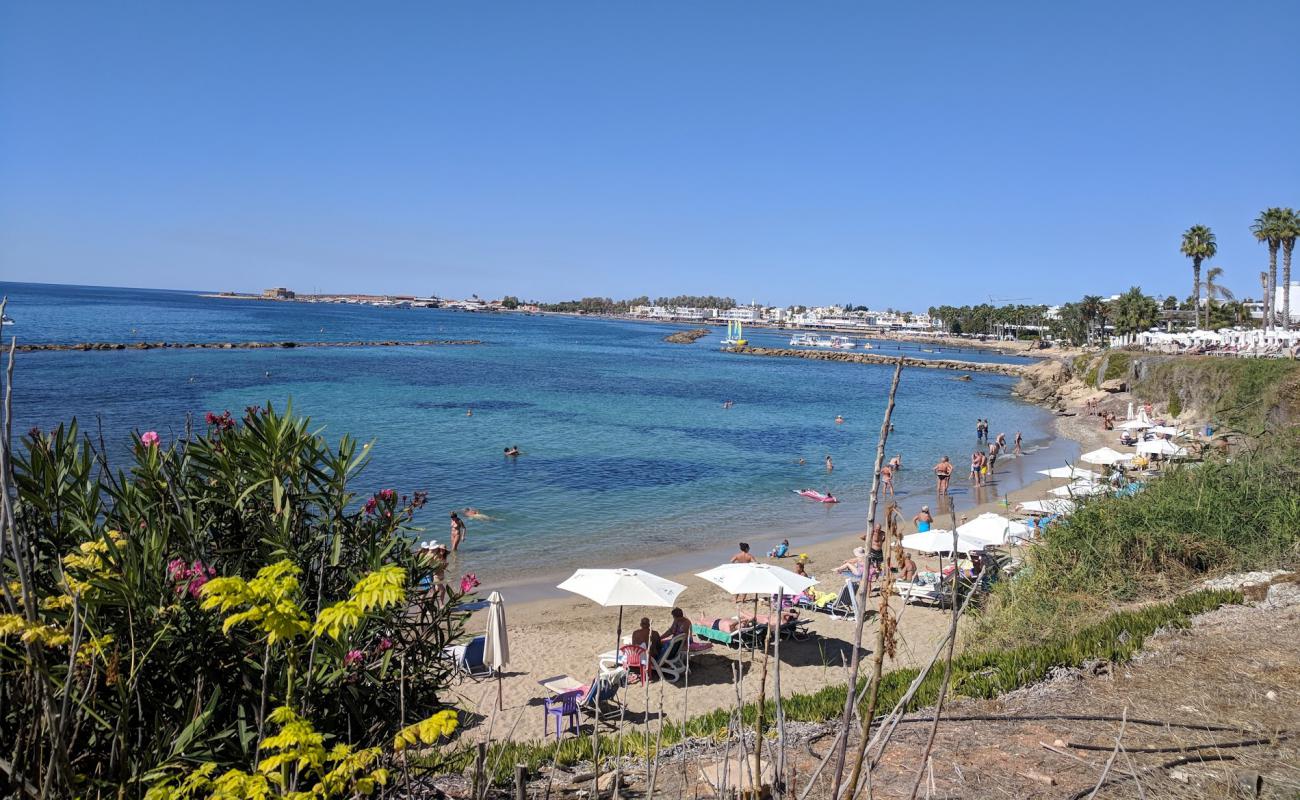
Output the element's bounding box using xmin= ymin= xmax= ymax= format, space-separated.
xmin=0 ymin=406 xmax=475 ymax=797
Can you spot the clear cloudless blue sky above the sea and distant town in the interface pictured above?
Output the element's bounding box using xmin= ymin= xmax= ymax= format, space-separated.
xmin=0 ymin=0 xmax=1300 ymax=308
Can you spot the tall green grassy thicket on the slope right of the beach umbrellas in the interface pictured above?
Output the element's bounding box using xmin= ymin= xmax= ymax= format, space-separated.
xmin=974 ymin=438 xmax=1300 ymax=647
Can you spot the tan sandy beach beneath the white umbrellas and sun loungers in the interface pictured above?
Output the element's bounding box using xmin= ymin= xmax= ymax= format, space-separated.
xmin=452 ymin=390 xmax=1109 ymax=739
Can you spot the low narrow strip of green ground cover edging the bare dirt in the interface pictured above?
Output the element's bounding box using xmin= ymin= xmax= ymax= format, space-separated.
xmin=439 ymin=592 xmax=1242 ymax=782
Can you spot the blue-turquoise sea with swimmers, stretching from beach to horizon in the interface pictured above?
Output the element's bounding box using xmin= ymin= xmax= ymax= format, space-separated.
xmin=0 ymin=282 xmax=1078 ymax=595
